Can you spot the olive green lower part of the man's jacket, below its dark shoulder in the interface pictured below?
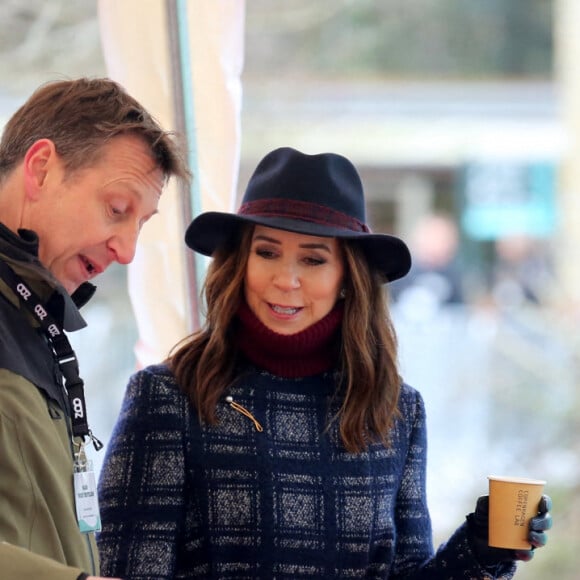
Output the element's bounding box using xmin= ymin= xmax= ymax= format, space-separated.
xmin=0 ymin=369 xmax=97 ymax=580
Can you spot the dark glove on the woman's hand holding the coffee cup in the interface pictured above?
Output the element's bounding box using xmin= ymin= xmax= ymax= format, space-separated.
xmin=467 ymin=495 xmax=552 ymax=566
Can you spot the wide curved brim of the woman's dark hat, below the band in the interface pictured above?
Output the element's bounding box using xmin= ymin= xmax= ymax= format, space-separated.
xmin=185 ymin=212 xmax=411 ymax=282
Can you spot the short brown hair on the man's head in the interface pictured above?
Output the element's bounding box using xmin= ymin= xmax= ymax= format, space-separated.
xmin=0 ymin=78 xmax=189 ymax=180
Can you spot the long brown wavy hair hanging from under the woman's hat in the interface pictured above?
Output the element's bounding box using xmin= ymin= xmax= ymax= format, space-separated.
xmin=167 ymin=226 xmax=400 ymax=453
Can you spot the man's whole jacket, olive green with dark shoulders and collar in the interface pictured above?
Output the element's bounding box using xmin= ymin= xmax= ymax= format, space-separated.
xmin=0 ymin=224 xmax=99 ymax=580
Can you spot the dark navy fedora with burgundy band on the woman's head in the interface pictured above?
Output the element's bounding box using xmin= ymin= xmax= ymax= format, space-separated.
xmin=185 ymin=147 xmax=411 ymax=281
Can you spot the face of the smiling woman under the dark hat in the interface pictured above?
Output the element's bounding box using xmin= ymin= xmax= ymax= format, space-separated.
xmin=244 ymin=226 xmax=344 ymax=334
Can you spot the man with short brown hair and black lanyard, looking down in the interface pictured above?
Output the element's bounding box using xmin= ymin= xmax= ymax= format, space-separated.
xmin=0 ymin=79 xmax=188 ymax=580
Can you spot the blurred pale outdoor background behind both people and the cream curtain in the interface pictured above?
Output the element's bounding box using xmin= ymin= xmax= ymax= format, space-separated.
xmin=0 ymin=0 xmax=580 ymax=580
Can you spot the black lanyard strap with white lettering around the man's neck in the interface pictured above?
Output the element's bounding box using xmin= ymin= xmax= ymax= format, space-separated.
xmin=0 ymin=259 xmax=103 ymax=451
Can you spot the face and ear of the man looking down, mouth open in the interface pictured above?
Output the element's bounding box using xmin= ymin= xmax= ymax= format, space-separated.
xmin=26 ymin=136 xmax=164 ymax=294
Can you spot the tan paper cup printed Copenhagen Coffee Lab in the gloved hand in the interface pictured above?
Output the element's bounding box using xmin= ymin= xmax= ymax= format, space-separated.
xmin=488 ymin=475 xmax=546 ymax=550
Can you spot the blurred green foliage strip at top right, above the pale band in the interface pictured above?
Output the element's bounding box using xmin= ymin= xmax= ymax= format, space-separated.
xmin=246 ymin=0 xmax=553 ymax=80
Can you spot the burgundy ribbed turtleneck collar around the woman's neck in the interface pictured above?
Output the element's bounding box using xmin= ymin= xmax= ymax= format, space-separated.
xmin=236 ymin=301 xmax=344 ymax=378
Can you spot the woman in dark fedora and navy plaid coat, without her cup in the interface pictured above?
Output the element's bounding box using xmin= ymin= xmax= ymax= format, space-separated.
xmin=99 ymin=148 xmax=550 ymax=579
